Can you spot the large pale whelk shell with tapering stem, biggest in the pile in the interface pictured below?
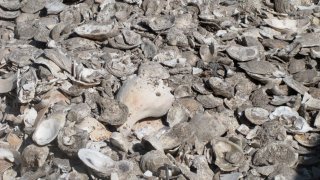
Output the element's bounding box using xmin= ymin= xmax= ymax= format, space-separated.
xmin=117 ymin=76 xmax=174 ymax=135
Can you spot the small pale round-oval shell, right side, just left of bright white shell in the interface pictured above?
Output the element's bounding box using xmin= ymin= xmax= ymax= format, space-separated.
xmin=244 ymin=107 xmax=269 ymax=125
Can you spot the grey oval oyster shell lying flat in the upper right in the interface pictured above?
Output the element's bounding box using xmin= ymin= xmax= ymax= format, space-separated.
xmin=226 ymin=46 xmax=259 ymax=62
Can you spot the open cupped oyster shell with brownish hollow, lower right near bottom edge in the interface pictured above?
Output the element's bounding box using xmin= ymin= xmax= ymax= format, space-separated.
xmin=212 ymin=138 xmax=245 ymax=171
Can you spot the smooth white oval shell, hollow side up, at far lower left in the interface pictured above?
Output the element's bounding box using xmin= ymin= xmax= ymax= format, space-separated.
xmin=32 ymin=112 xmax=66 ymax=146
